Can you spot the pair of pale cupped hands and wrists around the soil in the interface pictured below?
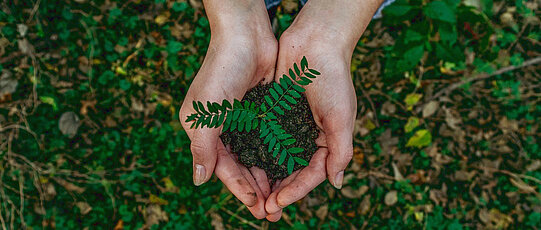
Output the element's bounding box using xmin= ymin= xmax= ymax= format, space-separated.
xmin=180 ymin=0 xmax=382 ymax=221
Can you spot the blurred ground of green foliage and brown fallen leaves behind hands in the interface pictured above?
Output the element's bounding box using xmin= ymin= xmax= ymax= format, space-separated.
xmin=0 ymin=0 xmax=541 ymax=229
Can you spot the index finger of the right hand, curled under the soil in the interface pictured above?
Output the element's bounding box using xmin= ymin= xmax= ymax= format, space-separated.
xmin=276 ymin=148 xmax=328 ymax=207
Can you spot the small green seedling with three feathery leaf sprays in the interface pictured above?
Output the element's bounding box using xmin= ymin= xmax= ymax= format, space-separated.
xmin=186 ymin=57 xmax=320 ymax=174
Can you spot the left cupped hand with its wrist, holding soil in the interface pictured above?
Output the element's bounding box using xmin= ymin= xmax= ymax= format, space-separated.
xmin=179 ymin=0 xmax=277 ymax=219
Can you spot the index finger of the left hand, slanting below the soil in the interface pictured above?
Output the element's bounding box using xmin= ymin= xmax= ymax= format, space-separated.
xmin=214 ymin=141 xmax=257 ymax=207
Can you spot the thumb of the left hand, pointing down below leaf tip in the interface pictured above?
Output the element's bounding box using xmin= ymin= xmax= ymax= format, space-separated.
xmin=190 ymin=128 xmax=217 ymax=186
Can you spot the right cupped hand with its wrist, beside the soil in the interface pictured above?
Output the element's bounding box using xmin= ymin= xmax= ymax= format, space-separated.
xmin=265 ymin=0 xmax=379 ymax=221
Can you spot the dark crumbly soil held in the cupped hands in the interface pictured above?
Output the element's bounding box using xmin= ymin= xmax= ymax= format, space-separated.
xmin=220 ymin=84 xmax=318 ymax=180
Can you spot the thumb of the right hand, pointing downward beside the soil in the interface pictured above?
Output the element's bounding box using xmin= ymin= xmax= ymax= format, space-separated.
xmin=323 ymin=115 xmax=353 ymax=189
